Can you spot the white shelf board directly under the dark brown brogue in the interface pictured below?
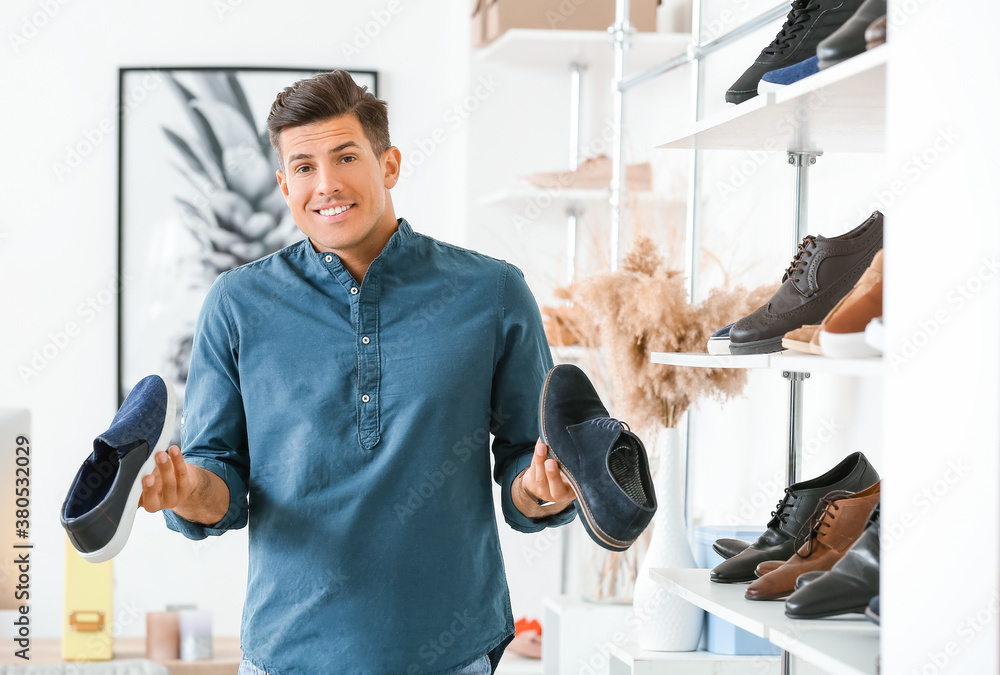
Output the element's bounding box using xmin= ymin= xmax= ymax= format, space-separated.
xmin=650 ymin=351 xmax=883 ymax=377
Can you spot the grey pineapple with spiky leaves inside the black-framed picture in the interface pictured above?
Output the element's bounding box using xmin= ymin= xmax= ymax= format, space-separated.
xmin=162 ymin=71 xmax=302 ymax=387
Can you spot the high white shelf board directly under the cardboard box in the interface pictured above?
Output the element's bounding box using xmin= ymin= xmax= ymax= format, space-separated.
xmin=476 ymin=28 xmax=691 ymax=71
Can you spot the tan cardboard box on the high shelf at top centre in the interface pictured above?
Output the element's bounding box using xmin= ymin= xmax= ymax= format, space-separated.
xmin=483 ymin=0 xmax=657 ymax=43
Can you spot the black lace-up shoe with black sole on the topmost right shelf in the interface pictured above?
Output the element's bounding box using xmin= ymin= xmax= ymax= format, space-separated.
xmin=726 ymin=0 xmax=862 ymax=103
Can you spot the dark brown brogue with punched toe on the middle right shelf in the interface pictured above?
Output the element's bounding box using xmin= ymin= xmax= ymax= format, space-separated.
xmin=729 ymin=211 xmax=882 ymax=356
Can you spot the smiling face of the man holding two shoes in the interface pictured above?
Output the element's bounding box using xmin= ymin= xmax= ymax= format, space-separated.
xmin=278 ymin=115 xmax=399 ymax=256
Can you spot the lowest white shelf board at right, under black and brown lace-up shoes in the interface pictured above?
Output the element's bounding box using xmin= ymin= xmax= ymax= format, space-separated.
xmin=650 ymin=569 xmax=879 ymax=675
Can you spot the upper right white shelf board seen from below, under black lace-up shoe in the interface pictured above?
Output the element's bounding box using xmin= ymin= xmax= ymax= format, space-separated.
xmin=656 ymin=45 xmax=889 ymax=152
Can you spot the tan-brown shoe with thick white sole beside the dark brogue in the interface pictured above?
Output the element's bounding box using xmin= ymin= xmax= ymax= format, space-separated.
xmin=819 ymin=250 xmax=884 ymax=358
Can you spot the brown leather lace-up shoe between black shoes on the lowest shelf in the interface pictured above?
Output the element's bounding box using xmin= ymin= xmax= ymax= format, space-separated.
xmin=746 ymin=481 xmax=881 ymax=600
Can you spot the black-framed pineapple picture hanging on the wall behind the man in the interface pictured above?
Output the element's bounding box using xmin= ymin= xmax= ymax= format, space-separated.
xmin=118 ymin=67 xmax=378 ymax=442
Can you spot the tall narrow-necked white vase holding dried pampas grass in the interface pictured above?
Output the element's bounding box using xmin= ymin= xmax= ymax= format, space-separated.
xmin=632 ymin=428 xmax=704 ymax=652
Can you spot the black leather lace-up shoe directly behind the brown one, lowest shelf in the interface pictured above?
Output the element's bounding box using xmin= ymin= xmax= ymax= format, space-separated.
xmin=711 ymin=452 xmax=879 ymax=584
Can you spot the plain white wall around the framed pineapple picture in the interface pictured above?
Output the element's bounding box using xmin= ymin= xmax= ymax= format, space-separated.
xmin=0 ymin=0 xmax=471 ymax=637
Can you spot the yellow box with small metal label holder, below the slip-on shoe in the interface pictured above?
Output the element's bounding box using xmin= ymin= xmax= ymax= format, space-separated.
xmin=62 ymin=537 xmax=114 ymax=661
